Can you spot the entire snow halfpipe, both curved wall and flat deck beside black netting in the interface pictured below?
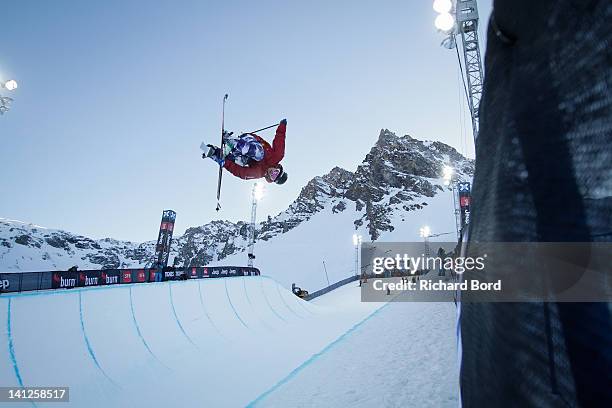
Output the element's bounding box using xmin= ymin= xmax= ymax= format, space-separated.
xmin=0 ymin=270 xmax=458 ymax=408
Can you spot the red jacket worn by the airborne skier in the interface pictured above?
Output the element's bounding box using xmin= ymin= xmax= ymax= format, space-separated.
xmin=223 ymin=123 xmax=287 ymax=180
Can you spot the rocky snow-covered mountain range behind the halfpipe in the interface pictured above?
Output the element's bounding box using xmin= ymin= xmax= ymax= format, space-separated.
xmin=0 ymin=130 xmax=474 ymax=291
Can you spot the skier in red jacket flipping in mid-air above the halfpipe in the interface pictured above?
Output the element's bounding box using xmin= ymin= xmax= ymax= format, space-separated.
xmin=200 ymin=119 xmax=287 ymax=184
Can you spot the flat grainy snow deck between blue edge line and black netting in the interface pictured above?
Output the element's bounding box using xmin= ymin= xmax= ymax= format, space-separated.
xmin=252 ymin=302 xmax=459 ymax=408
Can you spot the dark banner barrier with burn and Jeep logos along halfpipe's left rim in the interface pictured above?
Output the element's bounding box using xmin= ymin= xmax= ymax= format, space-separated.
xmin=0 ymin=266 xmax=260 ymax=293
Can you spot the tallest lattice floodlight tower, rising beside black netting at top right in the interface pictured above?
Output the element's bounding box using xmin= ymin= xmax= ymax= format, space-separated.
xmin=433 ymin=0 xmax=484 ymax=142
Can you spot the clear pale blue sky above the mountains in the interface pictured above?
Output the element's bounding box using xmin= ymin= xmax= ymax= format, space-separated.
xmin=0 ymin=0 xmax=490 ymax=240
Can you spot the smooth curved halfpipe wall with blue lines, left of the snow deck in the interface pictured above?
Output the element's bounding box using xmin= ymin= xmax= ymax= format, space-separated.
xmin=0 ymin=277 xmax=382 ymax=407
